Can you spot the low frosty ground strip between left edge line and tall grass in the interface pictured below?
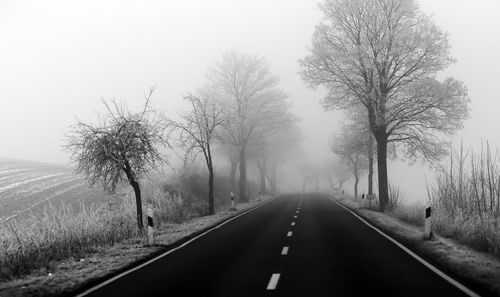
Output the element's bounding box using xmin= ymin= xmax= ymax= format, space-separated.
xmin=0 ymin=196 xmax=272 ymax=297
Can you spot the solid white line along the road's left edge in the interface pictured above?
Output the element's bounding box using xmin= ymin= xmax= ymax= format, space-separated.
xmin=75 ymin=198 xmax=279 ymax=297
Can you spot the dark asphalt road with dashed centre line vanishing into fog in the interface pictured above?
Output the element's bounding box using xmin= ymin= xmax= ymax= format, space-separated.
xmin=79 ymin=194 xmax=472 ymax=297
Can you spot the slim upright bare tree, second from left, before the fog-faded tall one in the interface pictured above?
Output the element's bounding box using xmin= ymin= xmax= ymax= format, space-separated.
xmin=168 ymin=91 xmax=224 ymax=215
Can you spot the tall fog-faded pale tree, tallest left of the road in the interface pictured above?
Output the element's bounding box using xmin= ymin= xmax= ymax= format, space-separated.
xmin=207 ymin=51 xmax=293 ymax=201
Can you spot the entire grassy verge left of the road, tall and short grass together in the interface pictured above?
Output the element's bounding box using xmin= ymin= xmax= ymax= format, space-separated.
xmin=0 ymin=182 xmax=271 ymax=297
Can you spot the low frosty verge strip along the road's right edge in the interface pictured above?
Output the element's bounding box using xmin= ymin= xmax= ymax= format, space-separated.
xmin=337 ymin=197 xmax=500 ymax=296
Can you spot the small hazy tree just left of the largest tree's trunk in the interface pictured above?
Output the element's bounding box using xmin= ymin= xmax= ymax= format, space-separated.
xmin=331 ymin=123 xmax=368 ymax=199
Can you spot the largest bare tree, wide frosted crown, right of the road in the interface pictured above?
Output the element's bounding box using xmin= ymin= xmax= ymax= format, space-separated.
xmin=301 ymin=0 xmax=469 ymax=210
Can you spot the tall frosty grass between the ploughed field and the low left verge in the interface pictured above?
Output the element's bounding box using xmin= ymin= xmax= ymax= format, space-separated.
xmin=0 ymin=178 xmax=187 ymax=281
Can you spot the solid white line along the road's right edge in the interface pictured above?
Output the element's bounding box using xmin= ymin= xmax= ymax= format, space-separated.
xmin=328 ymin=195 xmax=480 ymax=297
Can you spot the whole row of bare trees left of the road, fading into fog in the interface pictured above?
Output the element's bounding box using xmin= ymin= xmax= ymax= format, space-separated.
xmin=66 ymin=51 xmax=301 ymax=230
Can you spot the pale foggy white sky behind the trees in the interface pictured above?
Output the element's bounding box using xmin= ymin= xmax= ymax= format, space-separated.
xmin=0 ymin=0 xmax=500 ymax=200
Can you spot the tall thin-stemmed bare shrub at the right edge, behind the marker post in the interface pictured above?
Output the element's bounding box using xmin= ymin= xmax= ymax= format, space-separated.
xmin=428 ymin=142 xmax=500 ymax=257
